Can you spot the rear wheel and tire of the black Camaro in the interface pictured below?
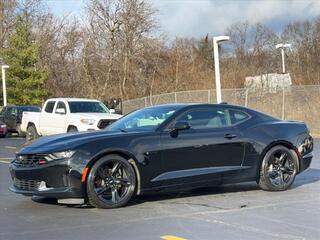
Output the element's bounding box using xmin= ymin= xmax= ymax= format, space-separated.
xmin=258 ymin=145 xmax=299 ymax=191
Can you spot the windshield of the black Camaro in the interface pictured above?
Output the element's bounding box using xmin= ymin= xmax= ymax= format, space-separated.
xmin=107 ymin=106 xmax=181 ymax=132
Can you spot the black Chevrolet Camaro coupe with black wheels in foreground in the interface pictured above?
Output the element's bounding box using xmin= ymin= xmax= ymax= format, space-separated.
xmin=9 ymin=104 xmax=313 ymax=208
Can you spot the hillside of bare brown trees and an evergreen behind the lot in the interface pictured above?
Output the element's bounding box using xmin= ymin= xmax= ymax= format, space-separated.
xmin=0 ymin=0 xmax=320 ymax=104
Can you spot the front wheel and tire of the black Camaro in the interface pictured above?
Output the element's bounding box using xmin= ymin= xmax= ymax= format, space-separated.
xmin=86 ymin=154 xmax=136 ymax=209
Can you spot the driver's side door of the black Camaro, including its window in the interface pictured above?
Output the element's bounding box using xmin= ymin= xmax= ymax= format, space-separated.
xmin=158 ymin=107 xmax=244 ymax=185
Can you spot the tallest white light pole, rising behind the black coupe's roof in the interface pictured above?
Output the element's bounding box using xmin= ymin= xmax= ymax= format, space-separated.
xmin=213 ymin=36 xmax=230 ymax=103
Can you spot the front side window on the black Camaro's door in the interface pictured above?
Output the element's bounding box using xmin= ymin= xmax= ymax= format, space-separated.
xmin=177 ymin=108 xmax=231 ymax=129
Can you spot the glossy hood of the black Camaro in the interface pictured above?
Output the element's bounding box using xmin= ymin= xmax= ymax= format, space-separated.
xmin=19 ymin=130 xmax=133 ymax=154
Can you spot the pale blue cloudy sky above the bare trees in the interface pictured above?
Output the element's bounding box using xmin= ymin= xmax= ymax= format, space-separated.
xmin=46 ymin=0 xmax=320 ymax=39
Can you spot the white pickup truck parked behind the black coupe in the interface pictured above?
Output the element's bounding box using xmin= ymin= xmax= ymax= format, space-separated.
xmin=21 ymin=98 xmax=121 ymax=141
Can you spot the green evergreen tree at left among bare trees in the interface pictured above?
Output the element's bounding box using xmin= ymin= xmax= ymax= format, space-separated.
xmin=3 ymin=15 xmax=48 ymax=105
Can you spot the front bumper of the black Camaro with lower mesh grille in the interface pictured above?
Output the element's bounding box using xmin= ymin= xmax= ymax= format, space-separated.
xmin=9 ymin=160 xmax=83 ymax=199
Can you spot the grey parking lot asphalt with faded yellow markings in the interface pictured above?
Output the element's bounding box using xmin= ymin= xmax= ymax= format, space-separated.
xmin=0 ymin=138 xmax=320 ymax=240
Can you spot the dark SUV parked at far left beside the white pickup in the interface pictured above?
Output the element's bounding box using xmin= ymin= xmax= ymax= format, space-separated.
xmin=0 ymin=106 xmax=41 ymax=136
